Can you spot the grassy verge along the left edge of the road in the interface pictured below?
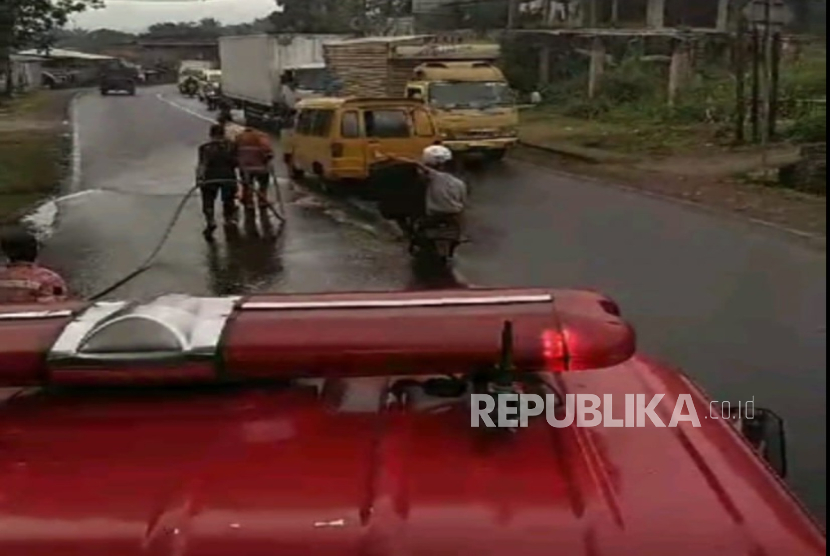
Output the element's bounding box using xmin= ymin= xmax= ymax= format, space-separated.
xmin=0 ymin=91 xmax=69 ymax=222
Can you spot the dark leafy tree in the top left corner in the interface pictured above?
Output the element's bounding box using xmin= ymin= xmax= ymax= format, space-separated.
xmin=0 ymin=0 xmax=104 ymax=95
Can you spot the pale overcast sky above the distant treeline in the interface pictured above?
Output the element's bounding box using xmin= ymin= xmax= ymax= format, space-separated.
xmin=70 ymin=0 xmax=276 ymax=31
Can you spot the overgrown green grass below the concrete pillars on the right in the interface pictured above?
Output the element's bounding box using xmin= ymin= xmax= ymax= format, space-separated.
xmin=520 ymin=42 xmax=826 ymax=158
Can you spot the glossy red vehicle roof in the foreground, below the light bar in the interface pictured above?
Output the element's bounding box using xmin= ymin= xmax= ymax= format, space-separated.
xmin=0 ymin=359 xmax=826 ymax=556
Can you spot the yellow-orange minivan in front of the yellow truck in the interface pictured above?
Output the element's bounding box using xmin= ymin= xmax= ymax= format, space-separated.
xmin=283 ymin=98 xmax=441 ymax=181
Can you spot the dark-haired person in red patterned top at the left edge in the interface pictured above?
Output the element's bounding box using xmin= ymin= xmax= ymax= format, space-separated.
xmin=0 ymin=227 xmax=68 ymax=303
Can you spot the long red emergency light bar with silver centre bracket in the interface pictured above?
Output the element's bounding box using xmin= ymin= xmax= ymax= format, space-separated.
xmin=0 ymin=290 xmax=636 ymax=386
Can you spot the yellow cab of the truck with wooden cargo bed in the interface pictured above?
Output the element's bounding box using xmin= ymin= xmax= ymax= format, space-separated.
xmin=406 ymin=61 xmax=519 ymax=159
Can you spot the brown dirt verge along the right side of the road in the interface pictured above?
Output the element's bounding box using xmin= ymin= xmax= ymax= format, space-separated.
xmin=515 ymin=111 xmax=827 ymax=243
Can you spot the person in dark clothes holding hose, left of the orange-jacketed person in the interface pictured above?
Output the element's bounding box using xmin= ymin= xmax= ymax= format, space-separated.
xmin=196 ymin=124 xmax=239 ymax=236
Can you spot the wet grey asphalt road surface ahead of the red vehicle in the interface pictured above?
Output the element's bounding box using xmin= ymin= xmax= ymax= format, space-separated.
xmin=30 ymin=84 xmax=826 ymax=523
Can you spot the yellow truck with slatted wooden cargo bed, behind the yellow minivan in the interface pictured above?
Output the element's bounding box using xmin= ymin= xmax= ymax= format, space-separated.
xmin=323 ymin=36 xmax=519 ymax=159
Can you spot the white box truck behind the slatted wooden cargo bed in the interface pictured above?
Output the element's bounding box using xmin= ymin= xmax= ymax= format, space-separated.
xmin=219 ymin=34 xmax=344 ymax=128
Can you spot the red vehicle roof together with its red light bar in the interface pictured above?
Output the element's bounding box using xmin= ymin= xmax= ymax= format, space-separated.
xmin=0 ymin=290 xmax=826 ymax=556
